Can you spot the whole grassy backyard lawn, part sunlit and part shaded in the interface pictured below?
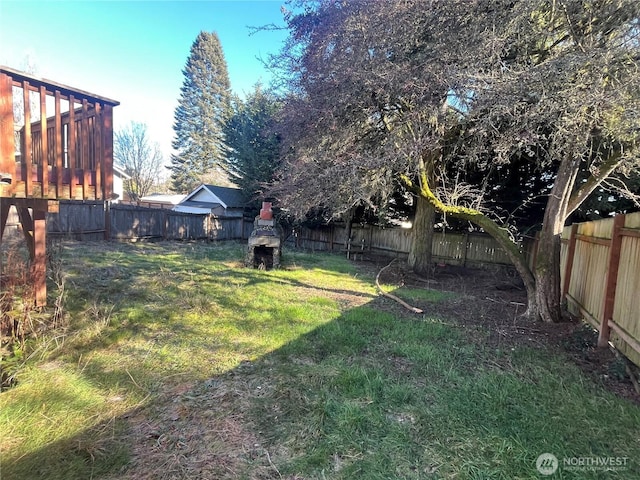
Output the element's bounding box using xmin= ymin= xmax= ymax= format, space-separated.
xmin=0 ymin=243 xmax=640 ymax=480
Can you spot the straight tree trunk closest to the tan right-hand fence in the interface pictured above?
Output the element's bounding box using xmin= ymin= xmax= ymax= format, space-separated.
xmin=534 ymin=157 xmax=579 ymax=322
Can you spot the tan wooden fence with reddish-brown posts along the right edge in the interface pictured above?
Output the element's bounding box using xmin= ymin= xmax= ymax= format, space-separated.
xmin=561 ymin=212 xmax=640 ymax=365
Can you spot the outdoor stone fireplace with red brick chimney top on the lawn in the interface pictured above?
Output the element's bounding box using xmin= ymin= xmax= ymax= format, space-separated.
xmin=245 ymin=202 xmax=282 ymax=270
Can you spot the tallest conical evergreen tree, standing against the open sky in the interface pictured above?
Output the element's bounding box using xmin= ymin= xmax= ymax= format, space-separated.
xmin=169 ymin=32 xmax=231 ymax=193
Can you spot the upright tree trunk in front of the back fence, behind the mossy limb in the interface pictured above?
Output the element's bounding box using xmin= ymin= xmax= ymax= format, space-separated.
xmin=407 ymin=195 xmax=436 ymax=277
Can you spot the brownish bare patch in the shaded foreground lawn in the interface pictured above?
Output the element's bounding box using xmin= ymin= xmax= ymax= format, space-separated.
xmin=113 ymin=372 xmax=282 ymax=480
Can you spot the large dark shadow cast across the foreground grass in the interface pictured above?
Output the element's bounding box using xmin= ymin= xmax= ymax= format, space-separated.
xmin=2 ymin=244 xmax=640 ymax=480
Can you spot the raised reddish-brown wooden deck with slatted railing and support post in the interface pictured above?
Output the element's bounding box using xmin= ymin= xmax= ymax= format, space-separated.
xmin=0 ymin=66 xmax=119 ymax=305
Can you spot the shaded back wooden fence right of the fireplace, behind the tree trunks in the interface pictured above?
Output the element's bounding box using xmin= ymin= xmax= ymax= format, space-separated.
xmin=291 ymin=225 xmax=533 ymax=267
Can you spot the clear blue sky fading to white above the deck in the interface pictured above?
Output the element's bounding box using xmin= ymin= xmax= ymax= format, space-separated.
xmin=0 ymin=0 xmax=286 ymax=161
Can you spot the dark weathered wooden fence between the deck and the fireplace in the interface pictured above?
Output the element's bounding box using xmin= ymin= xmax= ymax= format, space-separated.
xmin=7 ymin=201 xmax=253 ymax=241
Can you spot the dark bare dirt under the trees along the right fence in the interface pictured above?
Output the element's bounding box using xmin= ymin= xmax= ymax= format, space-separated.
xmin=370 ymin=258 xmax=640 ymax=404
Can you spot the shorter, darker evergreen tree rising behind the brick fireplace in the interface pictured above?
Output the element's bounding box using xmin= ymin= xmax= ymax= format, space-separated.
xmin=224 ymin=85 xmax=280 ymax=210
